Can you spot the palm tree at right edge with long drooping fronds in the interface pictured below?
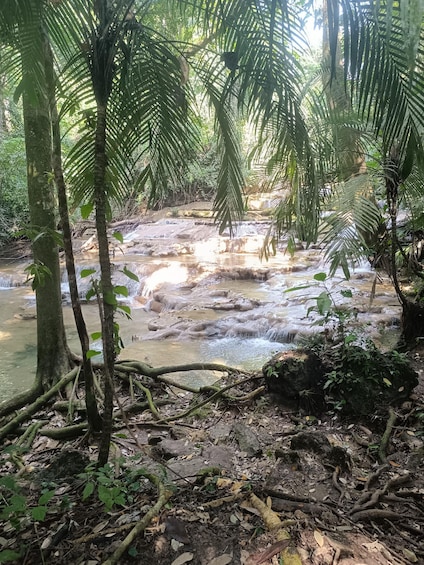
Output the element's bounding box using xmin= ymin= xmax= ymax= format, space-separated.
xmin=326 ymin=0 xmax=424 ymax=345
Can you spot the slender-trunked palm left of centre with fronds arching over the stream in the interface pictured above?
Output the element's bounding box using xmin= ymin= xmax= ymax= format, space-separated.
xmin=40 ymin=0 xmax=314 ymax=464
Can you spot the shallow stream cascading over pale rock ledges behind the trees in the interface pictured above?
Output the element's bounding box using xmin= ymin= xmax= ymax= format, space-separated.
xmin=0 ymin=209 xmax=400 ymax=401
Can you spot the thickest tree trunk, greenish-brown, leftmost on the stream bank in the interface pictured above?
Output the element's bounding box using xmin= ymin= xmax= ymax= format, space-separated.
xmin=22 ymin=28 xmax=69 ymax=390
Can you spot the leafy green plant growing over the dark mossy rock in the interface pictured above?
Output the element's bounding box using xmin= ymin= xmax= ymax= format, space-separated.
xmin=289 ymin=273 xmax=418 ymax=415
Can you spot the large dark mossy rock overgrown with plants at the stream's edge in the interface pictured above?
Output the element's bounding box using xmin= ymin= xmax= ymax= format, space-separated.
xmin=262 ymin=344 xmax=418 ymax=416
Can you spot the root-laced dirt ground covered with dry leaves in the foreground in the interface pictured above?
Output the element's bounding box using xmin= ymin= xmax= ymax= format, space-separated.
xmin=0 ymin=350 xmax=424 ymax=565
